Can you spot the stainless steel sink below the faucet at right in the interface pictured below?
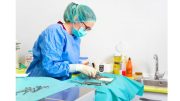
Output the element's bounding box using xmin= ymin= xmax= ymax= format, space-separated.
xmin=137 ymin=79 xmax=168 ymax=87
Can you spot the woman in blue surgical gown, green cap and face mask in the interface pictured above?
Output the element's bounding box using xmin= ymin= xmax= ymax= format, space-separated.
xmin=26 ymin=3 xmax=97 ymax=80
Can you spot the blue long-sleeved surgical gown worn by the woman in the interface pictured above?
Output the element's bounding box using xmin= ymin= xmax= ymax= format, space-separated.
xmin=26 ymin=24 xmax=81 ymax=80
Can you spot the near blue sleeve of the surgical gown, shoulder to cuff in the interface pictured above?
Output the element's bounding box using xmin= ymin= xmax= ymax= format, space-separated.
xmin=39 ymin=27 xmax=69 ymax=77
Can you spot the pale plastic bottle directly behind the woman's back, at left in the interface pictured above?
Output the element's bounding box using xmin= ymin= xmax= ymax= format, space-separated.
xmin=24 ymin=50 xmax=33 ymax=68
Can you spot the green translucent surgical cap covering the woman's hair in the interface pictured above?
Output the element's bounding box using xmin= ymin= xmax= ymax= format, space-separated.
xmin=64 ymin=2 xmax=96 ymax=23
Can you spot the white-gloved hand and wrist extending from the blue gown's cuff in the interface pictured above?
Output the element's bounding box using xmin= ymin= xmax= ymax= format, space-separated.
xmin=76 ymin=64 xmax=97 ymax=77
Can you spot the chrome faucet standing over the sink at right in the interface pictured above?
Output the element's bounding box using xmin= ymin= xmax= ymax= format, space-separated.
xmin=154 ymin=54 xmax=165 ymax=80
